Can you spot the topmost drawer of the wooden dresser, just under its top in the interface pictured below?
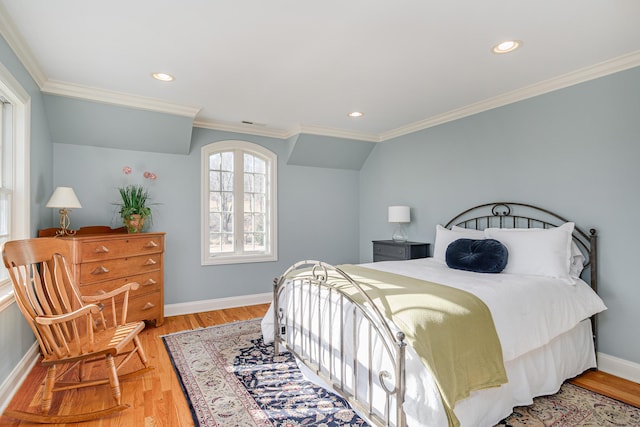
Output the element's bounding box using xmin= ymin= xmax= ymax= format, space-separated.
xmin=78 ymin=235 xmax=164 ymax=263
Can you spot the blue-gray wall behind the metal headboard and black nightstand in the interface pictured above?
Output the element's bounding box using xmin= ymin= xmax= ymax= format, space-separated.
xmin=360 ymin=68 xmax=640 ymax=363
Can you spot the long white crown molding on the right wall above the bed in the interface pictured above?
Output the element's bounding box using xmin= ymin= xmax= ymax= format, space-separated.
xmin=380 ymin=51 xmax=640 ymax=141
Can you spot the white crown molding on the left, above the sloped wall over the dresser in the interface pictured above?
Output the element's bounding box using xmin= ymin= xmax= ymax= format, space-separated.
xmin=41 ymin=80 xmax=200 ymax=119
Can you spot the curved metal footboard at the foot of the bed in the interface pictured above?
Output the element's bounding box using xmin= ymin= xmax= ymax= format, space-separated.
xmin=273 ymin=261 xmax=406 ymax=427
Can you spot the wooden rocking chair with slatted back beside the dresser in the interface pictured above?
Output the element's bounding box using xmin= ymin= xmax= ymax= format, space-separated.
xmin=2 ymin=238 xmax=153 ymax=423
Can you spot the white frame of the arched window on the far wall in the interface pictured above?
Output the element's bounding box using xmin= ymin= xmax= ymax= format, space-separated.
xmin=200 ymin=140 xmax=278 ymax=265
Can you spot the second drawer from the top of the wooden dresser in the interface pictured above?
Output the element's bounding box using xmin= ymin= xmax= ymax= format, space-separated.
xmin=79 ymin=254 xmax=162 ymax=286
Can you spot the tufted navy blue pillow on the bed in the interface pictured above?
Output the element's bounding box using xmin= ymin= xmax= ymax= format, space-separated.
xmin=445 ymin=239 xmax=509 ymax=273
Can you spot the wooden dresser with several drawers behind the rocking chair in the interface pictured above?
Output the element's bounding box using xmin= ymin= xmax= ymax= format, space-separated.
xmin=63 ymin=233 xmax=165 ymax=326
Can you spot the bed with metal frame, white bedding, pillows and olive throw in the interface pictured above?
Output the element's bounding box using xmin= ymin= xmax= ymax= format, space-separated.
xmin=262 ymin=202 xmax=606 ymax=427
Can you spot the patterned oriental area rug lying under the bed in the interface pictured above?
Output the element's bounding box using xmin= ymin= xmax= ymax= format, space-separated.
xmin=162 ymin=319 xmax=640 ymax=427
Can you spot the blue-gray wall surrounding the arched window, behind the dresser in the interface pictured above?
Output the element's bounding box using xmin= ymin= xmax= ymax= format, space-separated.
xmin=54 ymin=128 xmax=359 ymax=304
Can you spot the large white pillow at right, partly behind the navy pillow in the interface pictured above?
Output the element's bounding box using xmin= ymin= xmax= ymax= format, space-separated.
xmin=485 ymin=222 xmax=575 ymax=284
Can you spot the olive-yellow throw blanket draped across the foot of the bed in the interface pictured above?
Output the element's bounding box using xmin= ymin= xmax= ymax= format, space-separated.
xmin=330 ymin=265 xmax=507 ymax=426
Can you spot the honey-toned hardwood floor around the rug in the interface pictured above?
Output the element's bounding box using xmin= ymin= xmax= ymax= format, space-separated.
xmin=0 ymin=304 xmax=640 ymax=427
